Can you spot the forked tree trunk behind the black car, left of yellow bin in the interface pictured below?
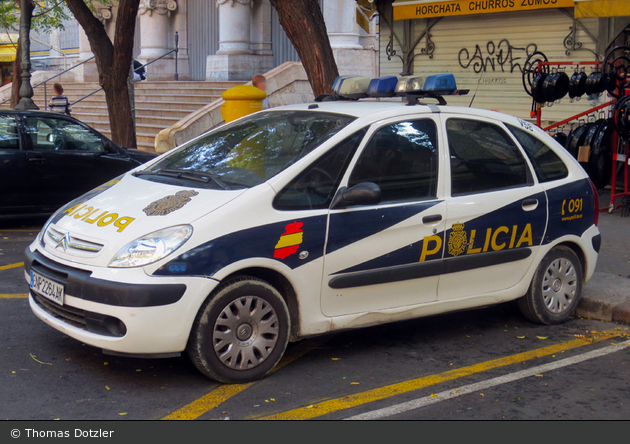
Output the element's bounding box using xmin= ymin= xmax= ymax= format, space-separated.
xmin=66 ymin=0 xmax=140 ymax=148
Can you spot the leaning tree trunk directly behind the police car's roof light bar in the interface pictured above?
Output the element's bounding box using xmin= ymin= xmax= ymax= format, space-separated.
xmin=270 ymin=0 xmax=339 ymax=97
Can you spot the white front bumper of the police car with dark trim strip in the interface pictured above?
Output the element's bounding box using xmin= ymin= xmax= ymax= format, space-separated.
xmin=25 ymin=244 xmax=218 ymax=354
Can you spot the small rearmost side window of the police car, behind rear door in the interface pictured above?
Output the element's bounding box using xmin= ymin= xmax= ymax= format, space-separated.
xmin=506 ymin=125 xmax=569 ymax=182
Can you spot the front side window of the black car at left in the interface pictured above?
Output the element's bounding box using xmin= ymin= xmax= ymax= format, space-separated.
xmin=26 ymin=117 xmax=105 ymax=153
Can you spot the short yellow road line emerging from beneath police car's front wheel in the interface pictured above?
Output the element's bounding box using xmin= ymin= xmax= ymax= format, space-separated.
xmin=162 ymin=335 xmax=332 ymax=420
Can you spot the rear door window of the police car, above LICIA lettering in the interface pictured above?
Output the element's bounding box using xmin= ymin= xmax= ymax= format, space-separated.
xmin=446 ymin=119 xmax=528 ymax=196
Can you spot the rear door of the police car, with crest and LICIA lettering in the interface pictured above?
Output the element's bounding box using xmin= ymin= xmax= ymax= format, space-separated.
xmin=438 ymin=114 xmax=547 ymax=300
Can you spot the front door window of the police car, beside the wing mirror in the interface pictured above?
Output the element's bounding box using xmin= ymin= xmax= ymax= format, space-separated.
xmin=348 ymin=119 xmax=438 ymax=202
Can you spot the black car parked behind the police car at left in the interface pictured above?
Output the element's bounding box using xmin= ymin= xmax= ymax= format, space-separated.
xmin=0 ymin=110 xmax=156 ymax=219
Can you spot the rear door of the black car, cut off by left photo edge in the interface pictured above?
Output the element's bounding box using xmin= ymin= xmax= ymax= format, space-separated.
xmin=0 ymin=114 xmax=29 ymax=216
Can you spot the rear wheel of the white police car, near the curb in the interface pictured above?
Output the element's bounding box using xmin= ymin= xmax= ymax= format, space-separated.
xmin=518 ymin=245 xmax=584 ymax=325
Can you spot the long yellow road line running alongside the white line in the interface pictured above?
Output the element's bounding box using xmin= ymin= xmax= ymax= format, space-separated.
xmin=250 ymin=332 xmax=621 ymax=420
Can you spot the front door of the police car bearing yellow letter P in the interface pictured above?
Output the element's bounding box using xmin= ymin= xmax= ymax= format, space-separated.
xmin=322 ymin=116 xmax=446 ymax=316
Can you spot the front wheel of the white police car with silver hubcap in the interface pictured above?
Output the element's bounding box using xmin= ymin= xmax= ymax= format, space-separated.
xmin=187 ymin=276 xmax=291 ymax=383
